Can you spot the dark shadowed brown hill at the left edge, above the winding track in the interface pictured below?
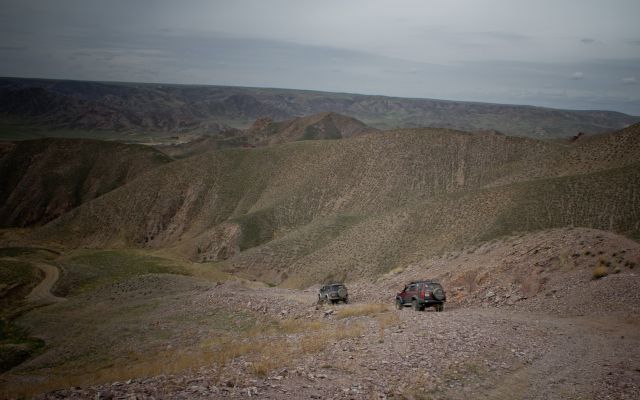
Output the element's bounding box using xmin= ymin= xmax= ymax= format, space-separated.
xmin=0 ymin=139 xmax=171 ymax=227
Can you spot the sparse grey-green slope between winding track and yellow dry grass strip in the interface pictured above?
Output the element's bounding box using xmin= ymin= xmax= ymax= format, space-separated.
xmin=16 ymin=274 xmax=258 ymax=376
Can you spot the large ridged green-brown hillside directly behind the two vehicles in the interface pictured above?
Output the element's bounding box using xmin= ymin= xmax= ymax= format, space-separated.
xmin=35 ymin=127 xmax=640 ymax=286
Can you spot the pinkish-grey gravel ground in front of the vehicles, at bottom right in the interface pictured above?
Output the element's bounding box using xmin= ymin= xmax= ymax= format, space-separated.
xmin=37 ymin=309 xmax=640 ymax=399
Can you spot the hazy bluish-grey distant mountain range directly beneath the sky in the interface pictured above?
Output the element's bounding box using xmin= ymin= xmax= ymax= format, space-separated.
xmin=0 ymin=78 xmax=640 ymax=138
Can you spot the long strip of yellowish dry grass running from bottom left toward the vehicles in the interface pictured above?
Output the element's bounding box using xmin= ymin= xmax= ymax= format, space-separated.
xmin=5 ymin=319 xmax=340 ymax=398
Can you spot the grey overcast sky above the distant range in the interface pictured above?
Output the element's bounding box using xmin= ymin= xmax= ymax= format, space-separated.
xmin=0 ymin=0 xmax=640 ymax=115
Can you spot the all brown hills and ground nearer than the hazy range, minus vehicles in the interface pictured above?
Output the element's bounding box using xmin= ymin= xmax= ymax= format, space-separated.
xmin=0 ymin=105 xmax=640 ymax=399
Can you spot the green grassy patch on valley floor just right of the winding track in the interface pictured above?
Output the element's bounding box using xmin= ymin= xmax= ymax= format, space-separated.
xmin=54 ymin=250 xmax=189 ymax=296
